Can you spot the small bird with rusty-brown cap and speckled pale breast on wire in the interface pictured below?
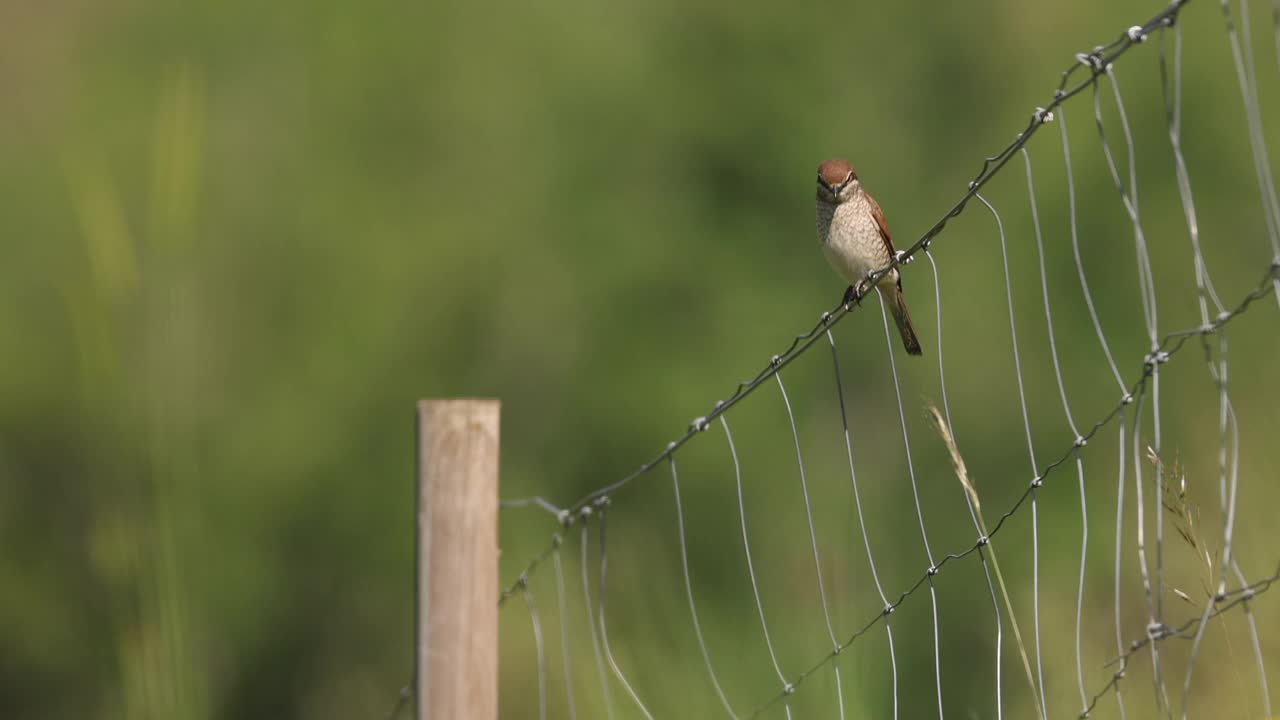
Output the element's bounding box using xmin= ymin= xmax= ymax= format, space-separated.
xmin=818 ymin=158 xmax=922 ymax=355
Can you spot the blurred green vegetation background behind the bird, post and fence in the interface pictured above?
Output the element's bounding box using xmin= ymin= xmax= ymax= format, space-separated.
xmin=0 ymin=0 xmax=1280 ymax=720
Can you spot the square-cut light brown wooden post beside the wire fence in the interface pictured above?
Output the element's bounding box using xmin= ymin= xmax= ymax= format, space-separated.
xmin=413 ymin=400 xmax=500 ymax=720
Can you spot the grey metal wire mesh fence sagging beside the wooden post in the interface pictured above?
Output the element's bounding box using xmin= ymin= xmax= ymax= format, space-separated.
xmin=392 ymin=0 xmax=1280 ymax=720
